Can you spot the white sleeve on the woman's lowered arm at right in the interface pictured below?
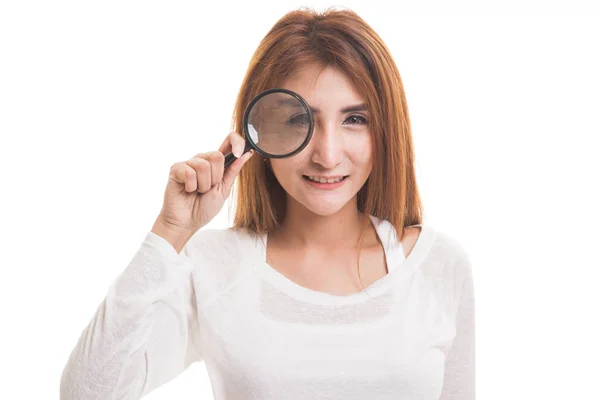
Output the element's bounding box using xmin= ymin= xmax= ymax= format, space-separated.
xmin=440 ymin=261 xmax=475 ymax=400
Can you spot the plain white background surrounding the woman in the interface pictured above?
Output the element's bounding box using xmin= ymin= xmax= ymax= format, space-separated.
xmin=0 ymin=0 xmax=600 ymax=400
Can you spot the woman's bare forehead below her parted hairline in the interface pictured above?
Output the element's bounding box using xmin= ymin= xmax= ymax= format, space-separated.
xmin=281 ymin=65 xmax=364 ymax=108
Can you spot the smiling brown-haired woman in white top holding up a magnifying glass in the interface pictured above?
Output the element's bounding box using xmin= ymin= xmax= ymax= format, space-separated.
xmin=61 ymin=10 xmax=475 ymax=400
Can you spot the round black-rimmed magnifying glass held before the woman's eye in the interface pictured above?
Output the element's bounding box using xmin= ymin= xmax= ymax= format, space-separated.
xmin=225 ymin=89 xmax=314 ymax=168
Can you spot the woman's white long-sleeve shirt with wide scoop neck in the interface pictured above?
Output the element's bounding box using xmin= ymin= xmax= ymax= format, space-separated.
xmin=61 ymin=217 xmax=475 ymax=400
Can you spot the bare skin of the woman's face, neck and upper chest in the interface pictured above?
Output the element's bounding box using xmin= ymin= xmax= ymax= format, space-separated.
xmin=267 ymin=66 xmax=420 ymax=295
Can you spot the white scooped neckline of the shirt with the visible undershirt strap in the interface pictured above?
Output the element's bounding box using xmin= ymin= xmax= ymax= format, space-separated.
xmin=255 ymin=216 xmax=435 ymax=305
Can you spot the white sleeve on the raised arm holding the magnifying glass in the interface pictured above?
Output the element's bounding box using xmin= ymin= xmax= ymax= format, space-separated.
xmin=60 ymin=232 xmax=202 ymax=400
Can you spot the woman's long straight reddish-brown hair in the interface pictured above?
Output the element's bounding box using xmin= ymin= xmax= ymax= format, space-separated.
xmin=232 ymin=8 xmax=423 ymax=239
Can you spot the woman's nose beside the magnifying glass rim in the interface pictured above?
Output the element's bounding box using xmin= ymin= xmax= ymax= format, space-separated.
xmin=311 ymin=121 xmax=344 ymax=169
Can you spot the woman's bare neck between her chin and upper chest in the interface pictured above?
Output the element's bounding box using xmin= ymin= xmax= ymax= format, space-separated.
xmin=274 ymin=201 xmax=368 ymax=250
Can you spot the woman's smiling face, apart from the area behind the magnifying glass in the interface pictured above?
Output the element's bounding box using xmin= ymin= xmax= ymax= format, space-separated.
xmin=270 ymin=66 xmax=372 ymax=216
